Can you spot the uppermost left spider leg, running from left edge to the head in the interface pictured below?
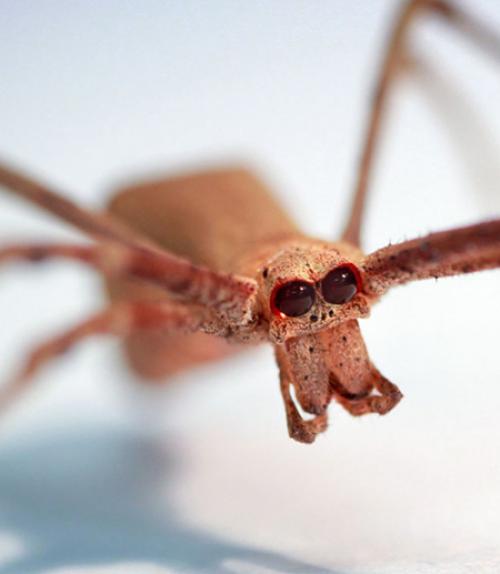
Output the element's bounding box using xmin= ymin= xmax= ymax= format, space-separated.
xmin=0 ymin=164 xmax=256 ymax=324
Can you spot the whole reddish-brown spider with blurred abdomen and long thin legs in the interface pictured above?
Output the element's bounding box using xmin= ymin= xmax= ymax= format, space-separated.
xmin=0 ymin=0 xmax=500 ymax=443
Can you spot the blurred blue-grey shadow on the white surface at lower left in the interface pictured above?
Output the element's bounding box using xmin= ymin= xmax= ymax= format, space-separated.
xmin=0 ymin=428 xmax=338 ymax=574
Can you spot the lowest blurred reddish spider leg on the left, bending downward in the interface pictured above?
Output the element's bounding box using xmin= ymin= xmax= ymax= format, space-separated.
xmin=0 ymin=302 xmax=204 ymax=412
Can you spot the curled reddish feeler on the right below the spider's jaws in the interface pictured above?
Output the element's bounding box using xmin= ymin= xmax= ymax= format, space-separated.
xmin=332 ymin=366 xmax=403 ymax=416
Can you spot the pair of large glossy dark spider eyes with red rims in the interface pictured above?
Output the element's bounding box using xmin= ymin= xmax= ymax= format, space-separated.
xmin=273 ymin=266 xmax=358 ymax=317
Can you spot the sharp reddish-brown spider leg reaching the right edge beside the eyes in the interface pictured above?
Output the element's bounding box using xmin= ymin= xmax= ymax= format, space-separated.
xmin=361 ymin=219 xmax=500 ymax=296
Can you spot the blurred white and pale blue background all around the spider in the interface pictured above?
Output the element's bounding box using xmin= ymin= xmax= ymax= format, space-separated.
xmin=0 ymin=0 xmax=500 ymax=574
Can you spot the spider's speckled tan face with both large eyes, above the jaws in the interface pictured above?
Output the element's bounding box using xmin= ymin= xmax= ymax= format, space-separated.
xmin=261 ymin=244 xmax=369 ymax=342
